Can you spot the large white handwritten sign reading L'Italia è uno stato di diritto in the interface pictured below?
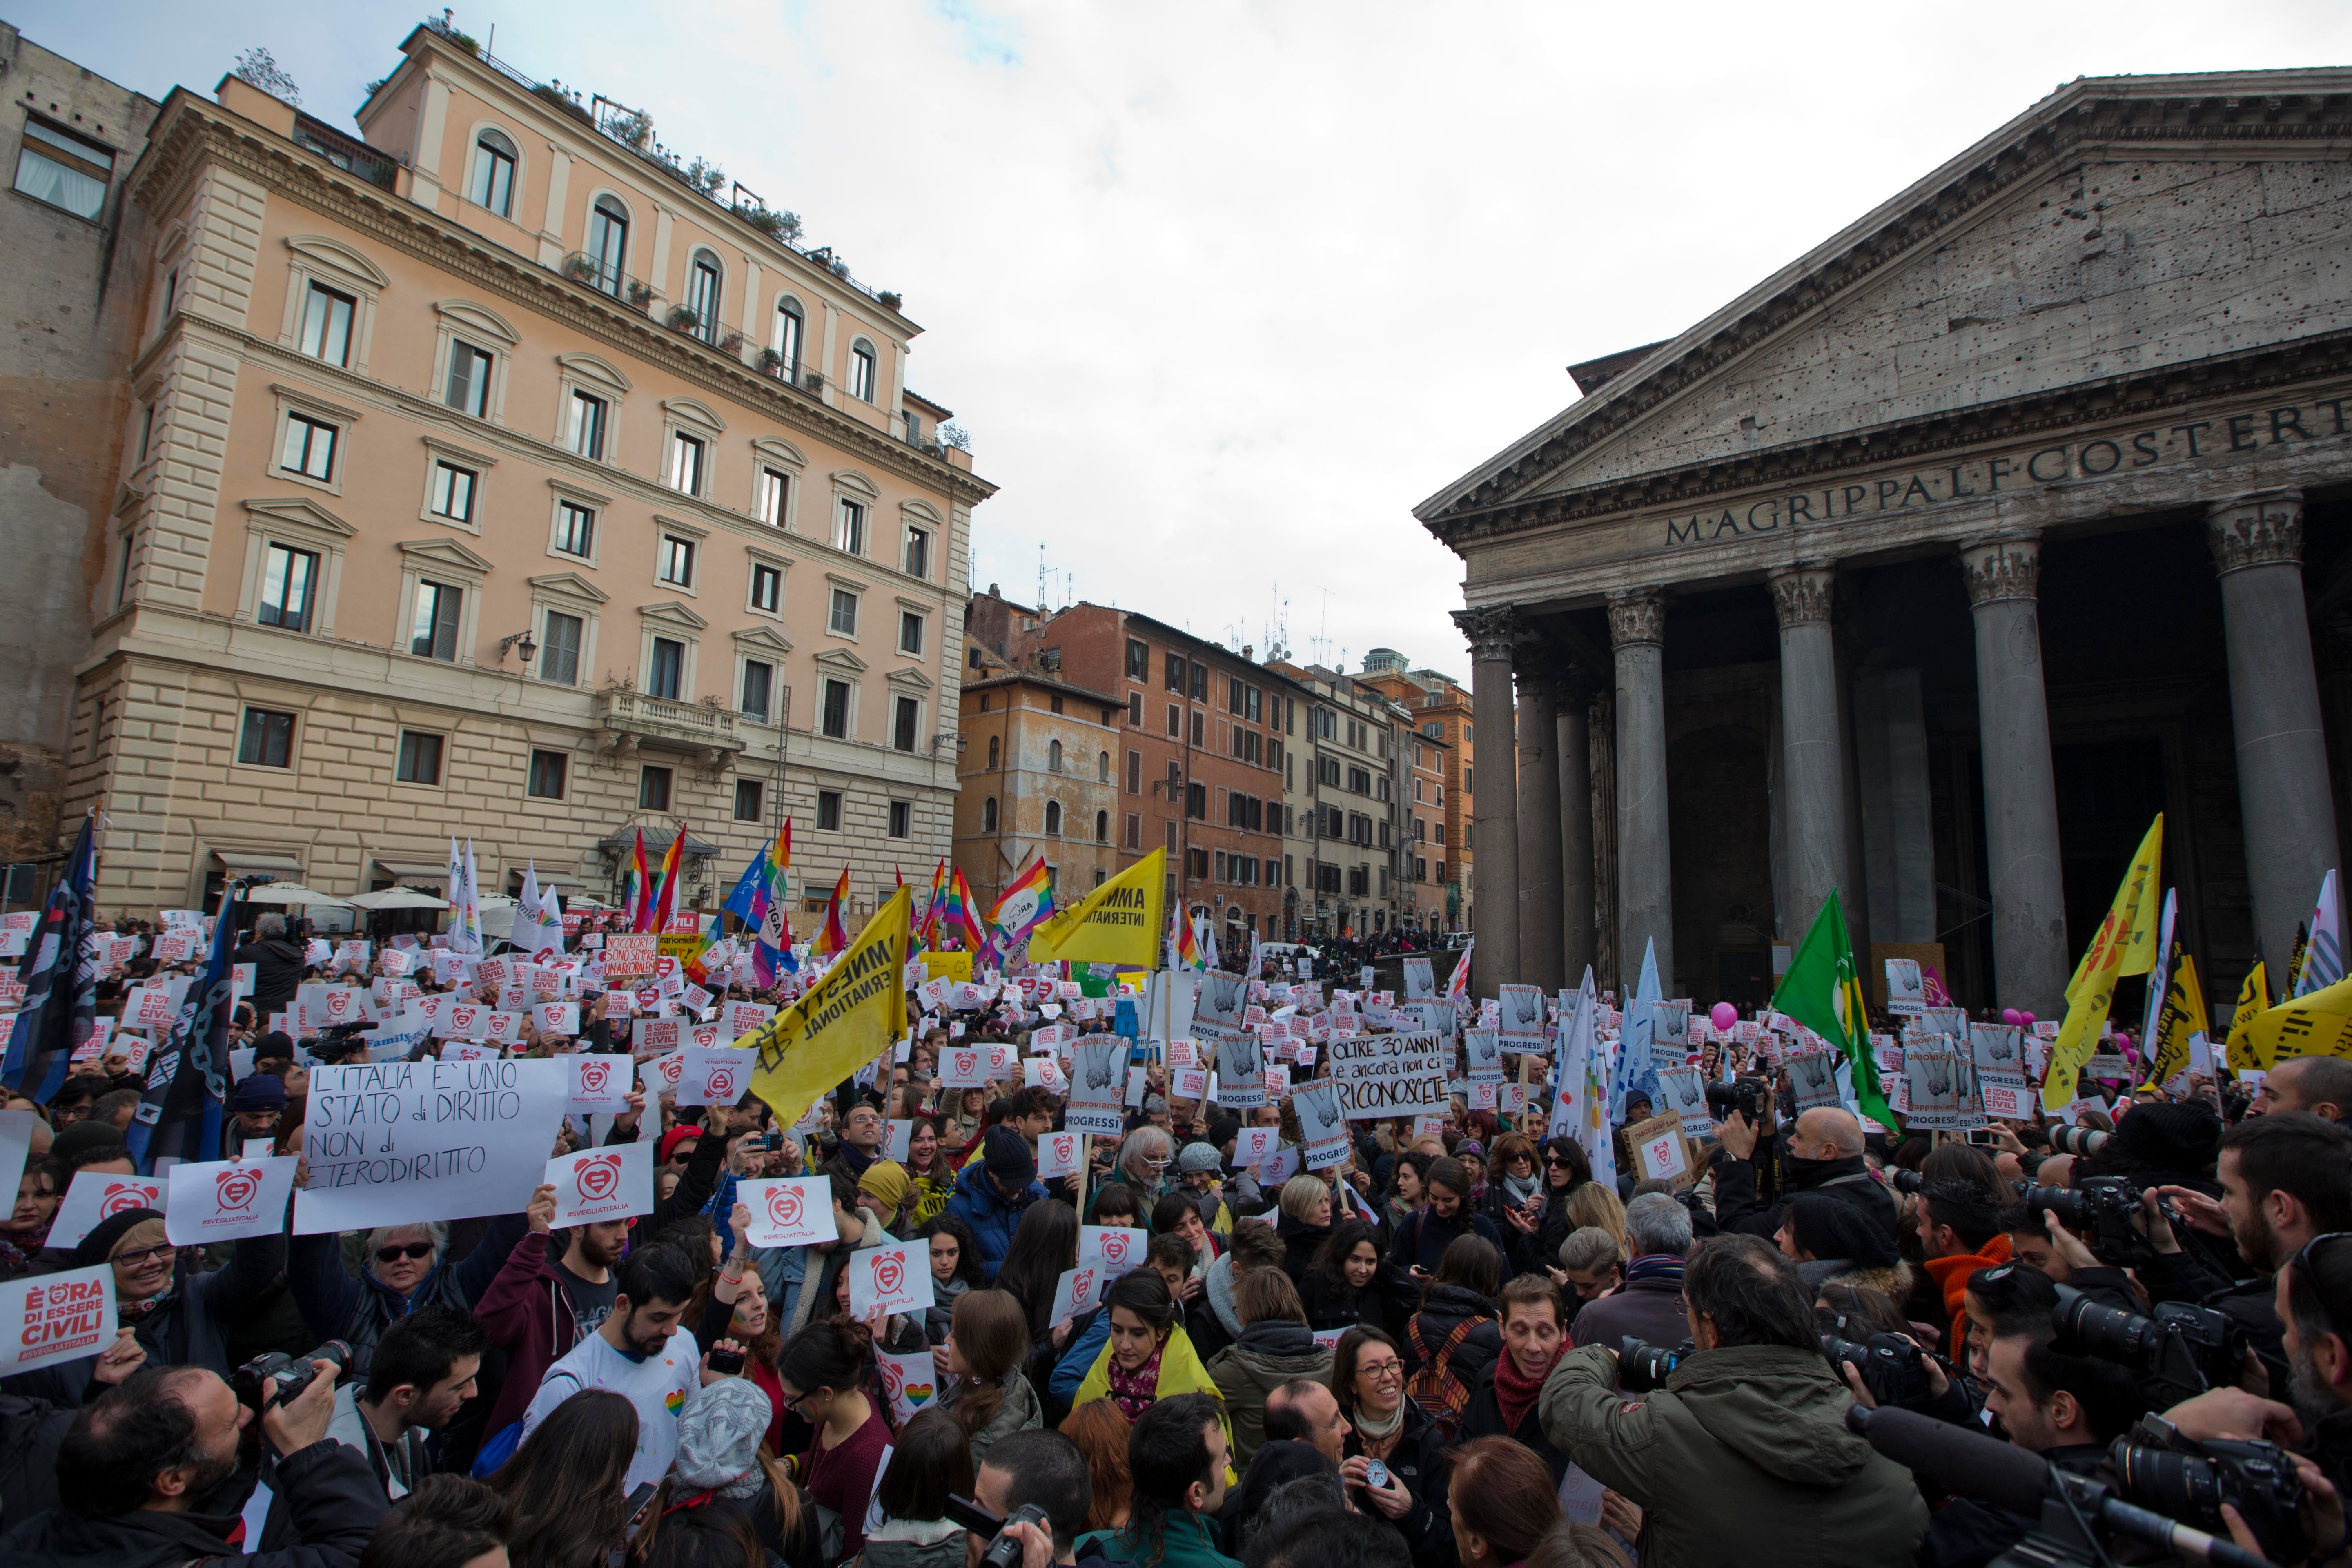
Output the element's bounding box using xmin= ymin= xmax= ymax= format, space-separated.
xmin=294 ymin=1060 xmax=572 ymax=1236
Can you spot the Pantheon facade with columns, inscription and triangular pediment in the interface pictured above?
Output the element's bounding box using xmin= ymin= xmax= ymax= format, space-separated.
xmin=1416 ymin=71 xmax=2352 ymax=1016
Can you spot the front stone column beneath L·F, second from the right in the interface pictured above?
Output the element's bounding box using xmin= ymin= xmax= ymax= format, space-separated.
xmin=1959 ymin=534 xmax=2069 ymax=1018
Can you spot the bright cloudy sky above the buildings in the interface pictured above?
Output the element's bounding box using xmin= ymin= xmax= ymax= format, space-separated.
xmin=32 ymin=0 xmax=2352 ymax=677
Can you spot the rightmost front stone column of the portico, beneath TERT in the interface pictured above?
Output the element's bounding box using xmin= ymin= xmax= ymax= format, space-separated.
xmin=2206 ymin=489 xmax=2338 ymax=990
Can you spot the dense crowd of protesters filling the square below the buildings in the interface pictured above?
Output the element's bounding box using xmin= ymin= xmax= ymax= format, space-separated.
xmin=0 ymin=917 xmax=2352 ymax=1568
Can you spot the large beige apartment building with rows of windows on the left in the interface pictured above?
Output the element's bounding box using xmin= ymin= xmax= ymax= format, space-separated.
xmin=68 ymin=26 xmax=993 ymax=915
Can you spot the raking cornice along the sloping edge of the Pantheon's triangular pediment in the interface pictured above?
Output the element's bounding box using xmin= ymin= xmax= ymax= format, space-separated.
xmin=1414 ymin=71 xmax=2352 ymax=548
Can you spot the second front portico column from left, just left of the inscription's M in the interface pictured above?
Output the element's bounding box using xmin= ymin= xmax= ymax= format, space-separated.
xmin=1609 ymin=588 xmax=1679 ymax=997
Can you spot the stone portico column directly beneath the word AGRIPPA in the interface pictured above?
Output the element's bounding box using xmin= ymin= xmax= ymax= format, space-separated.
xmin=1771 ymin=562 xmax=1846 ymax=943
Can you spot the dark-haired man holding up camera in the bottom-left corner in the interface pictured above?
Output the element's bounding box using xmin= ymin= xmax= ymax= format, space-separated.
xmin=0 ymin=1361 xmax=388 ymax=1568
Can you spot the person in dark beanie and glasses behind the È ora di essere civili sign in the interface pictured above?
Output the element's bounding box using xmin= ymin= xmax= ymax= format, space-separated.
xmin=0 ymin=1208 xmax=287 ymax=1406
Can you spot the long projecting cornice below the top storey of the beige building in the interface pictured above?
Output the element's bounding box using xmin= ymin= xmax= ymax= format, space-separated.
xmin=132 ymin=89 xmax=997 ymax=506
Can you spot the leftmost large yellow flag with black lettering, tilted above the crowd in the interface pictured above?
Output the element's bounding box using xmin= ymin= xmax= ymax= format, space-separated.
xmin=739 ymin=886 xmax=913 ymax=1126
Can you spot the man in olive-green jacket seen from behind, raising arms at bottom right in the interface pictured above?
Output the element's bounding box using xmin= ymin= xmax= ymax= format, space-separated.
xmin=1541 ymin=1236 xmax=1926 ymax=1568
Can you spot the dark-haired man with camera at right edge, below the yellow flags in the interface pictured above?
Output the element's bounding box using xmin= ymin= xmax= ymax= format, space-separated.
xmin=2140 ymin=1112 xmax=2352 ymax=1399
